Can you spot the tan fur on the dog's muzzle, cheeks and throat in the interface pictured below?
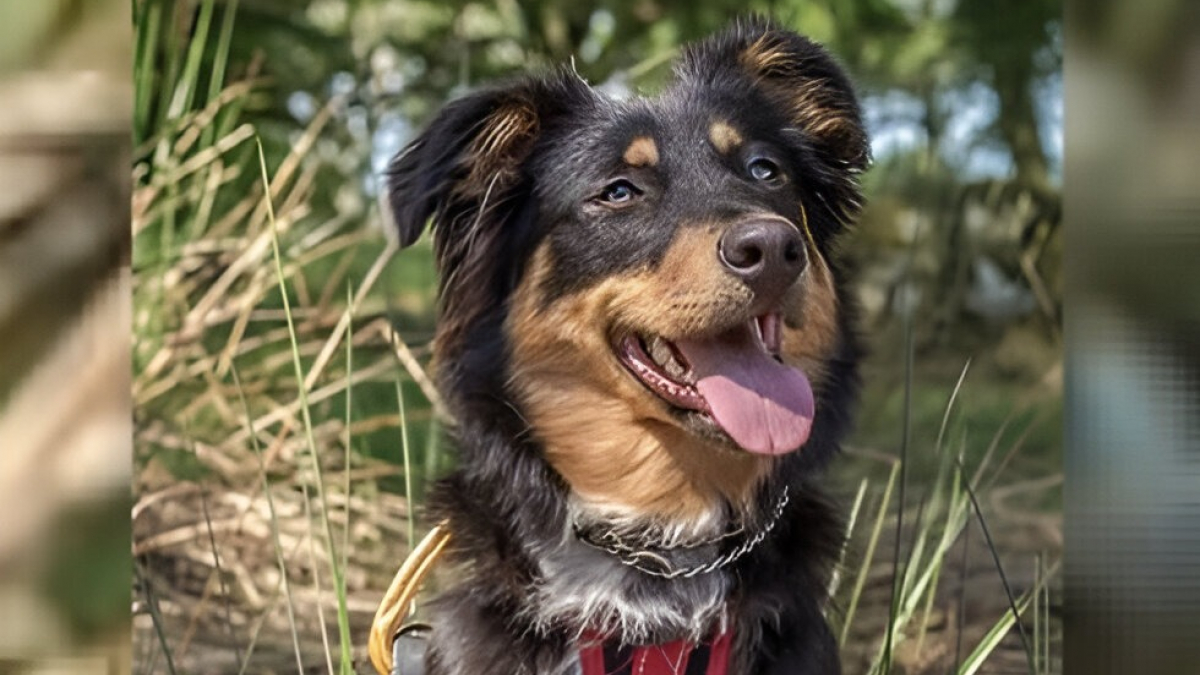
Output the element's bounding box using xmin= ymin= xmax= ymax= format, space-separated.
xmin=506 ymin=218 xmax=838 ymax=520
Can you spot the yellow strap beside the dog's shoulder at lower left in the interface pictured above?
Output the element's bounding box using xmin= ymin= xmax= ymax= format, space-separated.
xmin=367 ymin=520 xmax=450 ymax=675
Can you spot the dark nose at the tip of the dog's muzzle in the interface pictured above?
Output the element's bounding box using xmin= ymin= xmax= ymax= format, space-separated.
xmin=720 ymin=220 xmax=806 ymax=299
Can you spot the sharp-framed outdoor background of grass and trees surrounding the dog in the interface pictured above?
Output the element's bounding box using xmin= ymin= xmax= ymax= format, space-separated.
xmin=132 ymin=0 xmax=1064 ymax=673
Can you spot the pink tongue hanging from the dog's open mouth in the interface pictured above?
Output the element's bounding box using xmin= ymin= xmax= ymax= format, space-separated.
xmin=676 ymin=324 xmax=815 ymax=455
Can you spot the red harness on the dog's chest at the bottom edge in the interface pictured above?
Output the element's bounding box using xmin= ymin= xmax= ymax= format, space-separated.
xmin=580 ymin=632 xmax=733 ymax=675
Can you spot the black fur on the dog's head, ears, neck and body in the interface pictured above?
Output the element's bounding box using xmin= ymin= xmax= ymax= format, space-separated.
xmin=389 ymin=19 xmax=868 ymax=675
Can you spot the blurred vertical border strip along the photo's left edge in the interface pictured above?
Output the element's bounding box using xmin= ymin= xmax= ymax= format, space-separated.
xmin=0 ymin=0 xmax=132 ymax=674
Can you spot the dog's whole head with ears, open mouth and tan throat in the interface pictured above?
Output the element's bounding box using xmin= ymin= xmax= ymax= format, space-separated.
xmin=390 ymin=22 xmax=868 ymax=519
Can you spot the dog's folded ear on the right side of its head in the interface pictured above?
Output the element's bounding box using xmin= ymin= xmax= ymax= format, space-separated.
xmin=677 ymin=17 xmax=870 ymax=220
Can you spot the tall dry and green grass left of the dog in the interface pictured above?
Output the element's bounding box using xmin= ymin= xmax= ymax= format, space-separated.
xmin=132 ymin=2 xmax=439 ymax=673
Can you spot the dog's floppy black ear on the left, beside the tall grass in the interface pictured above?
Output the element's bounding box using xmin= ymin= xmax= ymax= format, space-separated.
xmin=386 ymin=71 xmax=593 ymax=356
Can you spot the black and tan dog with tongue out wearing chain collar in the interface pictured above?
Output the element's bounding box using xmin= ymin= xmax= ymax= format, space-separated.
xmin=385 ymin=18 xmax=870 ymax=675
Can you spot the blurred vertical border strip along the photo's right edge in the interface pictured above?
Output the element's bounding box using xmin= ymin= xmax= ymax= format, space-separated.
xmin=1064 ymin=0 xmax=1200 ymax=675
